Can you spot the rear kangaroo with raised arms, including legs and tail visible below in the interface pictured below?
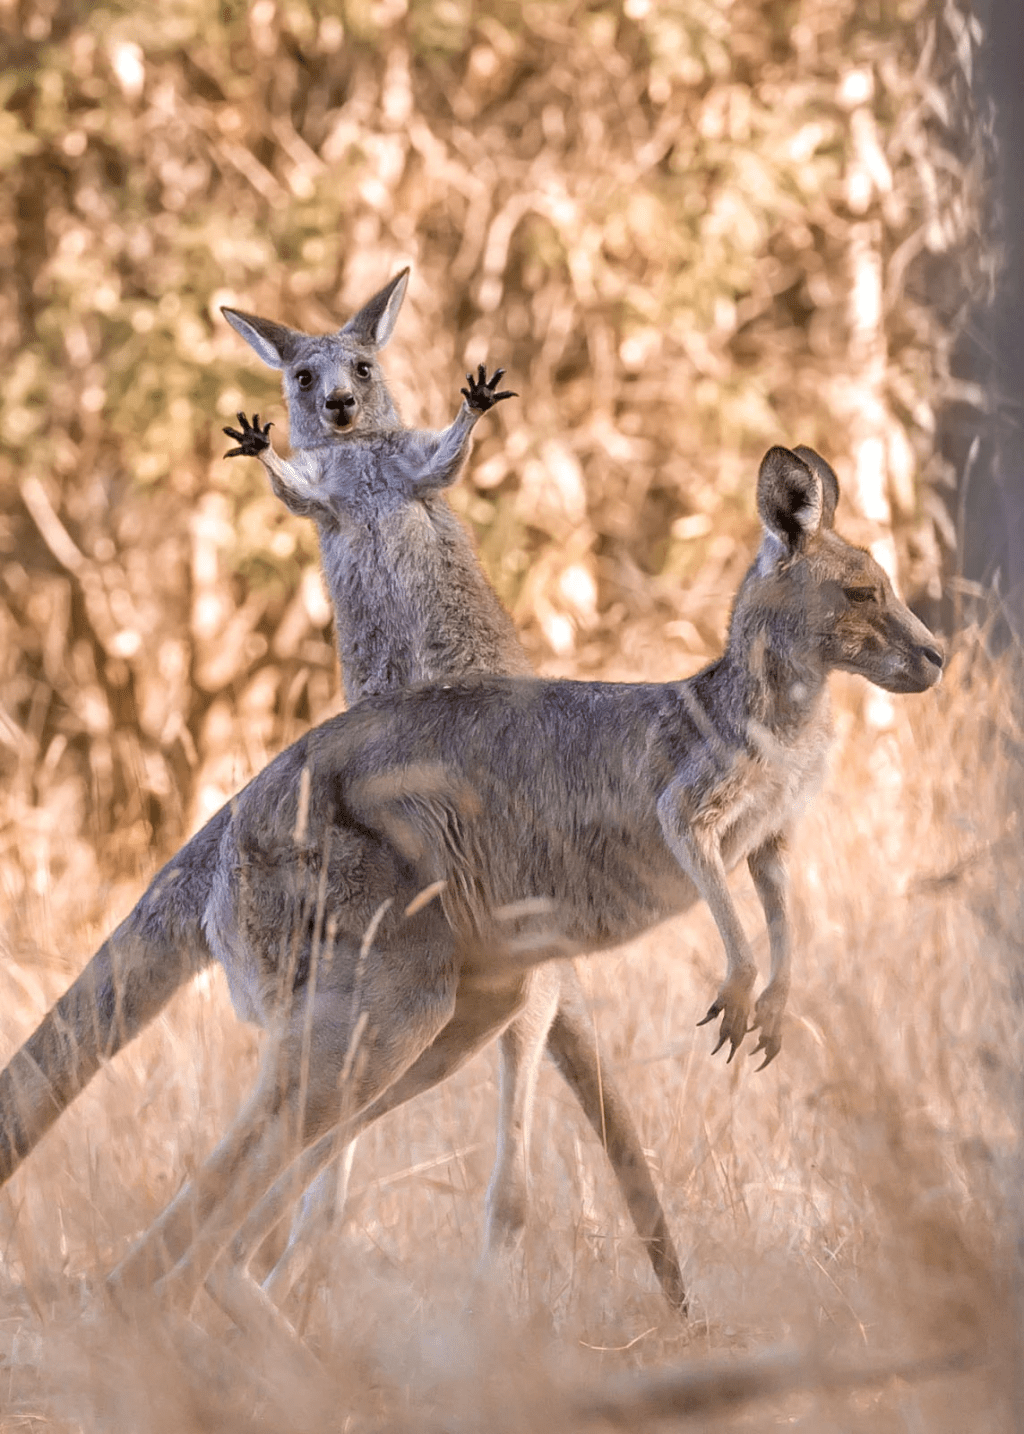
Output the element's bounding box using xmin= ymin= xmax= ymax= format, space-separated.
xmin=221 ymin=268 xmax=684 ymax=1306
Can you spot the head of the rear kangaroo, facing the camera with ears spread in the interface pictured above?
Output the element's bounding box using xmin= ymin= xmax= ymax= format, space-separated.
xmin=221 ymin=268 xmax=409 ymax=449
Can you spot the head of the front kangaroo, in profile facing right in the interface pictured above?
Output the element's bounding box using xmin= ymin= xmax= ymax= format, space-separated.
xmin=730 ymin=447 xmax=942 ymax=693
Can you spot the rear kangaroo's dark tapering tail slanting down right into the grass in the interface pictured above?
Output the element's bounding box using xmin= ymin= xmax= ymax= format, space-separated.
xmin=548 ymin=962 xmax=687 ymax=1314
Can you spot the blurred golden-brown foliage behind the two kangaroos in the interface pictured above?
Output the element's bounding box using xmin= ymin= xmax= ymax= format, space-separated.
xmin=0 ymin=0 xmax=990 ymax=903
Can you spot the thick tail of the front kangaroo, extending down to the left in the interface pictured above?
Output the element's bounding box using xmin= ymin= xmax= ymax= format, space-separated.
xmin=0 ymin=809 xmax=228 ymax=1184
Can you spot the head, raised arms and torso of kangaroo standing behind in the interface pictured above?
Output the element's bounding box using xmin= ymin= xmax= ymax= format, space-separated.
xmin=222 ymin=270 xmax=531 ymax=703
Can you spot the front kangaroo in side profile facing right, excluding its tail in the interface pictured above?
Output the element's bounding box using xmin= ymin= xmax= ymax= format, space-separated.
xmin=57 ymin=447 xmax=944 ymax=1306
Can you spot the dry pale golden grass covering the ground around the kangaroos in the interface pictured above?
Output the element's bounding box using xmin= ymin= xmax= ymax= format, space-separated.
xmin=0 ymin=628 xmax=1024 ymax=1434
